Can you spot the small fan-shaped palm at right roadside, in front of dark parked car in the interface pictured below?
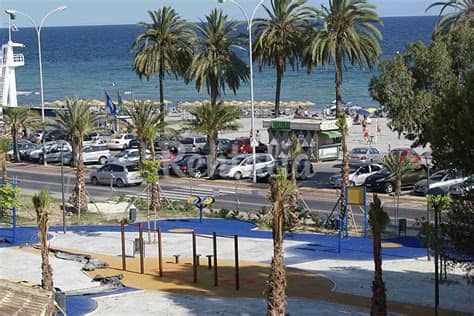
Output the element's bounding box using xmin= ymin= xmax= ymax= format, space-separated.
xmin=382 ymin=151 xmax=413 ymax=219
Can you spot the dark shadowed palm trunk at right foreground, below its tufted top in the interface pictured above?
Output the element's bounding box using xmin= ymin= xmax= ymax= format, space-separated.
xmin=370 ymin=225 xmax=387 ymax=316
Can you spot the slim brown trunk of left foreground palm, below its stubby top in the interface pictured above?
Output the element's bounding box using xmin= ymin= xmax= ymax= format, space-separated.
xmin=37 ymin=208 xmax=53 ymax=291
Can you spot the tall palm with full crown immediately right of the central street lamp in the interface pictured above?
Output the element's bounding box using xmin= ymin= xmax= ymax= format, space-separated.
xmin=254 ymin=0 xmax=314 ymax=116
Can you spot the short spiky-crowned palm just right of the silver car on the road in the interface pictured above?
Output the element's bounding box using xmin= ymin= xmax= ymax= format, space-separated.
xmin=124 ymin=101 xmax=166 ymax=164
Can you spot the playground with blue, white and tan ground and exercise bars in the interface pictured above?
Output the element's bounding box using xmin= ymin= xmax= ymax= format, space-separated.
xmin=0 ymin=218 xmax=473 ymax=315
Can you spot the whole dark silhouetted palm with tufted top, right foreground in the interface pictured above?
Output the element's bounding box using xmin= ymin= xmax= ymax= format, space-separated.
xmin=369 ymin=194 xmax=390 ymax=315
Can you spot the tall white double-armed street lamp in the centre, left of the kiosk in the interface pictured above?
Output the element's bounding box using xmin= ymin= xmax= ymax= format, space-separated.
xmin=218 ymin=0 xmax=265 ymax=183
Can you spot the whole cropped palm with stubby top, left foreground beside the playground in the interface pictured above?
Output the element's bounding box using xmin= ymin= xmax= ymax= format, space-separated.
xmin=32 ymin=188 xmax=53 ymax=291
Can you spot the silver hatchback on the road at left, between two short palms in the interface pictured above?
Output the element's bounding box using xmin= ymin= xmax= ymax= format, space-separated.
xmin=90 ymin=163 xmax=143 ymax=187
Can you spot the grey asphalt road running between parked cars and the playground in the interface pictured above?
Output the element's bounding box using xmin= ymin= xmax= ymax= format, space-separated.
xmin=9 ymin=164 xmax=426 ymax=226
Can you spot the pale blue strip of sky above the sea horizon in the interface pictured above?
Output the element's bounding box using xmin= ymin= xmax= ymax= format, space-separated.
xmin=0 ymin=0 xmax=438 ymax=27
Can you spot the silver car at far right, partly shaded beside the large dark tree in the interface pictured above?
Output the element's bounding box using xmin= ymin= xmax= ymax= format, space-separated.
xmin=413 ymin=170 xmax=467 ymax=195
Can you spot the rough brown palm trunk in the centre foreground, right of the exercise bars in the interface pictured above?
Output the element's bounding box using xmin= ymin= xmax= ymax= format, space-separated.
xmin=267 ymin=198 xmax=286 ymax=316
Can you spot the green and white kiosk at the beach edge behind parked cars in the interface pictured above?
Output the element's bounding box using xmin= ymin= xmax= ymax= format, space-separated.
xmin=263 ymin=118 xmax=342 ymax=161
